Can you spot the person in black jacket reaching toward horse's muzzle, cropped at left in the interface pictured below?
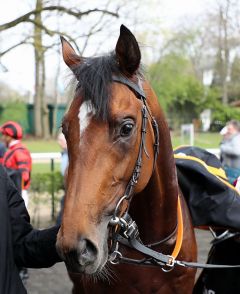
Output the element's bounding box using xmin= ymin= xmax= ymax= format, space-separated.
xmin=0 ymin=165 xmax=61 ymax=294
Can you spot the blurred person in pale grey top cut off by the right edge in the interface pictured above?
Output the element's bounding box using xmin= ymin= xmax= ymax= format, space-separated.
xmin=220 ymin=120 xmax=240 ymax=183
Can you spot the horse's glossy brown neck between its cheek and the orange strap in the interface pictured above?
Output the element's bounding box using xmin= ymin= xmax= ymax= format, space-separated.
xmin=131 ymin=112 xmax=178 ymax=243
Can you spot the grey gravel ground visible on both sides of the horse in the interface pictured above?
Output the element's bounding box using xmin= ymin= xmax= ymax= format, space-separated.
xmin=24 ymin=230 xmax=212 ymax=294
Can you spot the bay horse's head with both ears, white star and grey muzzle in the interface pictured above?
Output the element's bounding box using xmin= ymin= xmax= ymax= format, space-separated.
xmin=57 ymin=26 xmax=165 ymax=274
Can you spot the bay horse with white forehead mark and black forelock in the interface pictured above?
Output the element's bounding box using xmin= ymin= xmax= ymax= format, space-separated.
xmin=57 ymin=25 xmax=196 ymax=294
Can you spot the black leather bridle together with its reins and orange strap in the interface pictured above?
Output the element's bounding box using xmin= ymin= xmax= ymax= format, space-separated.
xmin=109 ymin=75 xmax=240 ymax=272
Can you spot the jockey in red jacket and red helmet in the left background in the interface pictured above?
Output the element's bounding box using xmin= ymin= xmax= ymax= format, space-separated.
xmin=0 ymin=121 xmax=32 ymax=207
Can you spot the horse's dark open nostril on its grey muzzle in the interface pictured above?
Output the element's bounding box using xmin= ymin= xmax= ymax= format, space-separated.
xmin=77 ymin=239 xmax=98 ymax=265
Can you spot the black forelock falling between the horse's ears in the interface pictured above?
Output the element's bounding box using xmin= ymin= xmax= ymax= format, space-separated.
xmin=73 ymin=53 xmax=142 ymax=120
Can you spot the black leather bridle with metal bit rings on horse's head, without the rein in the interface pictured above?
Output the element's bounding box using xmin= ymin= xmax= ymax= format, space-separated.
xmin=109 ymin=76 xmax=182 ymax=271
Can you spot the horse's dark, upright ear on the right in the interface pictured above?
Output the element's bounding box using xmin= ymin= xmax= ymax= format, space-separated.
xmin=115 ymin=25 xmax=141 ymax=75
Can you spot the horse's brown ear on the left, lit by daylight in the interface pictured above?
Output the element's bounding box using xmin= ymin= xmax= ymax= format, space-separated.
xmin=60 ymin=36 xmax=81 ymax=69
